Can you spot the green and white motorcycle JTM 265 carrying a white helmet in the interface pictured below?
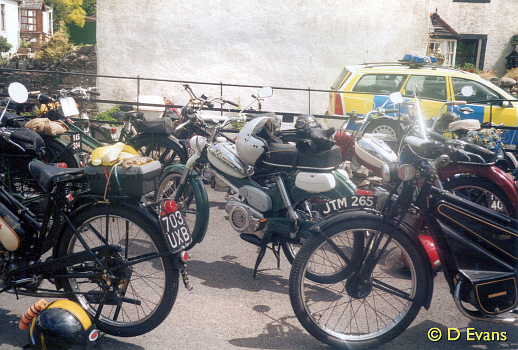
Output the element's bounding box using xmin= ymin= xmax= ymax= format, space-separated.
xmin=156 ymin=88 xmax=362 ymax=277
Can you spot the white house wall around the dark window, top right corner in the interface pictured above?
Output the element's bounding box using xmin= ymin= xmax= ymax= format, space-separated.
xmin=429 ymin=0 xmax=518 ymax=74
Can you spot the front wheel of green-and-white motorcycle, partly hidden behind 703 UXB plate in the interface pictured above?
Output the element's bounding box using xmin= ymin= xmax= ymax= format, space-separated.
xmin=155 ymin=167 xmax=209 ymax=250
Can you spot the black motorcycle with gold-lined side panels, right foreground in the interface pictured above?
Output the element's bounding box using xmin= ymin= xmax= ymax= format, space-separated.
xmin=290 ymin=136 xmax=518 ymax=348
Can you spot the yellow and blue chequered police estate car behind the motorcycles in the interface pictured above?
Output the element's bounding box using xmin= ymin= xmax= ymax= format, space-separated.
xmin=326 ymin=61 xmax=518 ymax=149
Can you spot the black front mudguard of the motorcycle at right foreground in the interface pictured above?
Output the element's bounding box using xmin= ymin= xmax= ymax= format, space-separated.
xmin=310 ymin=209 xmax=433 ymax=309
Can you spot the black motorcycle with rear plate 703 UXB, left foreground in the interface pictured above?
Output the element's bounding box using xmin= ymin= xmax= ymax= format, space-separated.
xmin=0 ymin=128 xmax=191 ymax=337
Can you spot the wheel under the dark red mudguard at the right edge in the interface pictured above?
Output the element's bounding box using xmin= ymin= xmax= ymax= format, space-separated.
xmin=443 ymin=175 xmax=516 ymax=217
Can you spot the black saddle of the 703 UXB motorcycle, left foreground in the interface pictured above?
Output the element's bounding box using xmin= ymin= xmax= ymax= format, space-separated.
xmin=29 ymin=160 xmax=84 ymax=191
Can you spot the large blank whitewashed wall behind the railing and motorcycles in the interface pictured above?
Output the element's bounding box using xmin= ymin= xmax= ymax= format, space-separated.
xmin=97 ymin=0 xmax=429 ymax=113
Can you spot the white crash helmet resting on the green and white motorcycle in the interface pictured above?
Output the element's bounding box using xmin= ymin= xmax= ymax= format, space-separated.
xmin=236 ymin=117 xmax=274 ymax=166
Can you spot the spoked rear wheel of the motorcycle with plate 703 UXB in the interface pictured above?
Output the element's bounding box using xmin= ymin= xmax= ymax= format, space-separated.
xmin=58 ymin=203 xmax=178 ymax=337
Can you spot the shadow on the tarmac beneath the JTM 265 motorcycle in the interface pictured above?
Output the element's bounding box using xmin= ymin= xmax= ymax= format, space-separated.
xmin=189 ymin=255 xmax=288 ymax=294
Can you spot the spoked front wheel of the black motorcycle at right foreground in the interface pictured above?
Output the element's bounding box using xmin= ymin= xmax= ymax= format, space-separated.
xmin=289 ymin=214 xmax=429 ymax=348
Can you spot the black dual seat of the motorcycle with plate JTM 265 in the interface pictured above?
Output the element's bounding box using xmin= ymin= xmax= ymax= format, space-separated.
xmin=262 ymin=143 xmax=342 ymax=171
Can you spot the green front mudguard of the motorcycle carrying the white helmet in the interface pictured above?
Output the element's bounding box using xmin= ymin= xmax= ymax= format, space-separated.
xmin=162 ymin=163 xmax=209 ymax=243
